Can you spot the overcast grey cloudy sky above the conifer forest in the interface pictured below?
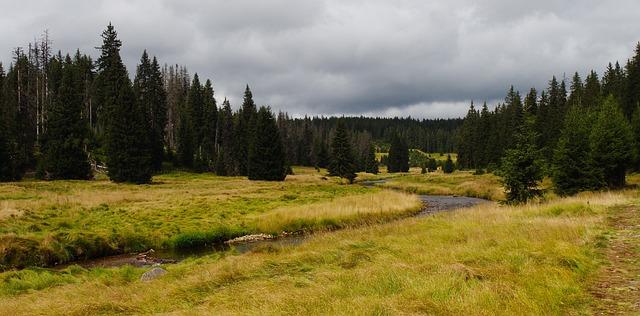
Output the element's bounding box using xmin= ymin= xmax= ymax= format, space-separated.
xmin=0 ymin=0 xmax=640 ymax=118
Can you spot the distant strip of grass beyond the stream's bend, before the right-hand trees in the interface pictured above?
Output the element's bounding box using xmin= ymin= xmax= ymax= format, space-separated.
xmin=381 ymin=169 xmax=504 ymax=201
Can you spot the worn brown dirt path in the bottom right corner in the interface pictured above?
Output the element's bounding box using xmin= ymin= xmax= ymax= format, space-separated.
xmin=590 ymin=205 xmax=640 ymax=315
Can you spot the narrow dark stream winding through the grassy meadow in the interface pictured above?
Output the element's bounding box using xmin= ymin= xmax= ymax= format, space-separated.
xmin=53 ymin=180 xmax=490 ymax=270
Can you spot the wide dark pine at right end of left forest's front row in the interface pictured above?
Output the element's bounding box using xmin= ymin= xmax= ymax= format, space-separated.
xmin=248 ymin=106 xmax=287 ymax=181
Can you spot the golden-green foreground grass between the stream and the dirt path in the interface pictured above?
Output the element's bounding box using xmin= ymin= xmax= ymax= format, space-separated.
xmin=0 ymin=191 xmax=638 ymax=315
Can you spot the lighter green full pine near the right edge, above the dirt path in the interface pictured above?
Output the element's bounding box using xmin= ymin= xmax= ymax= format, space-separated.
xmin=590 ymin=95 xmax=635 ymax=188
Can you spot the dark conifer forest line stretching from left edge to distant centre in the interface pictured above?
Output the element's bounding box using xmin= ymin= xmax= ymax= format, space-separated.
xmin=0 ymin=24 xmax=462 ymax=183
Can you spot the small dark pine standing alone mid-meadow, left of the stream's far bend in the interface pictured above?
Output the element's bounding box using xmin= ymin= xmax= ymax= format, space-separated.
xmin=329 ymin=121 xmax=356 ymax=183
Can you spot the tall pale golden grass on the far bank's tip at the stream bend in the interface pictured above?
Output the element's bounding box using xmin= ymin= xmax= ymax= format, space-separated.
xmin=256 ymin=191 xmax=422 ymax=233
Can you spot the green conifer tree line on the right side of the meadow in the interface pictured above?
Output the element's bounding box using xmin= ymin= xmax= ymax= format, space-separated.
xmin=458 ymin=43 xmax=640 ymax=202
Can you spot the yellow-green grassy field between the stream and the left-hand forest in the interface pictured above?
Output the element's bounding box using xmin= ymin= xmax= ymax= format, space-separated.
xmin=0 ymin=168 xmax=420 ymax=268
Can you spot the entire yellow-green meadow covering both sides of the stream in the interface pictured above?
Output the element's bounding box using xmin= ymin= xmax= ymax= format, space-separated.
xmin=0 ymin=168 xmax=640 ymax=315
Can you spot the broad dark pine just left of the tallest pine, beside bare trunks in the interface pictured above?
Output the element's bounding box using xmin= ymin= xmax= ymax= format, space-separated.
xmin=40 ymin=55 xmax=91 ymax=179
